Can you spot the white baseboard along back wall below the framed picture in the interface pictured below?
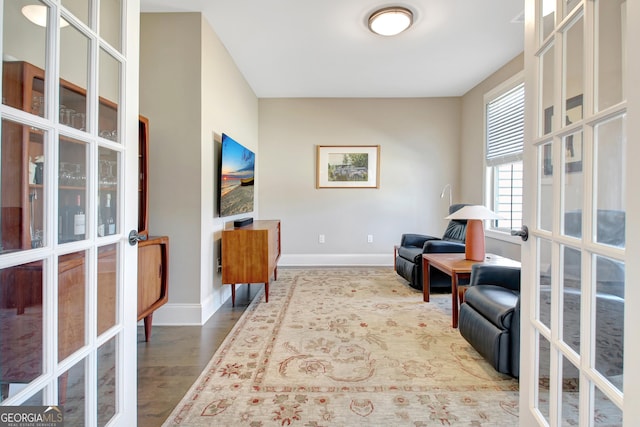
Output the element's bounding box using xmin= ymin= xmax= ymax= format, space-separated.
xmin=278 ymin=252 xmax=393 ymax=267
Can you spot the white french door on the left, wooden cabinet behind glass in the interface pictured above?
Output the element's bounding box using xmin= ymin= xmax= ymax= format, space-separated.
xmin=0 ymin=0 xmax=139 ymax=426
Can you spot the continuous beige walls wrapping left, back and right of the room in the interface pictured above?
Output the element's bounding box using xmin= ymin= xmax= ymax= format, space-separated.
xmin=140 ymin=13 xmax=522 ymax=324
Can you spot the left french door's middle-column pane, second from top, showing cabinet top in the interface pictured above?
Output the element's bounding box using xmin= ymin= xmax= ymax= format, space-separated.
xmin=58 ymin=21 xmax=89 ymax=130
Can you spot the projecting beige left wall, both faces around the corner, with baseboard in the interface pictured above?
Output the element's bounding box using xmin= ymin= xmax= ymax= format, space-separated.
xmin=140 ymin=13 xmax=258 ymax=324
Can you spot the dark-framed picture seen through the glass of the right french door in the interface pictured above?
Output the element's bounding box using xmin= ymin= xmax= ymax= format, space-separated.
xmin=543 ymin=95 xmax=583 ymax=176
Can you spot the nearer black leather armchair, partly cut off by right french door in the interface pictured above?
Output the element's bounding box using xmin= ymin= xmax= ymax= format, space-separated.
xmin=458 ymin=264 xmax=520 ymax=378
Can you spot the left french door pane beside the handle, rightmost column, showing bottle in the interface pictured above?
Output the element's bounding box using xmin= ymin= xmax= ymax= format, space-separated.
xmin=97 ymin=147 xmax=120 ymax=237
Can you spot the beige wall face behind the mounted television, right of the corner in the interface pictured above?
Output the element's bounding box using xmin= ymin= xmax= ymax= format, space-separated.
xmin=199 ymin=12 xmax=260 ymax=321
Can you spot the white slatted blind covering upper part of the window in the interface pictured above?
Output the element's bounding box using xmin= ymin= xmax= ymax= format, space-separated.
xmin=486 ymin=83 xmax=524 ymax=166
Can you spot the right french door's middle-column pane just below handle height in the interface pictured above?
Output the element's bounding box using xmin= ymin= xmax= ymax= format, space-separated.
xmin=561 ymin=246 xmax=582 ymax=354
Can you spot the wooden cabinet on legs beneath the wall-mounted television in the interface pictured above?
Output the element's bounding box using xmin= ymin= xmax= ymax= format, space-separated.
xmin=222 ymin=220 xmax=280 ymax=306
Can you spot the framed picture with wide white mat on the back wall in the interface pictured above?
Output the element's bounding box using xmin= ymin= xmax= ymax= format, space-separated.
xmin=316 ymin=145 xmax=380 ymax=188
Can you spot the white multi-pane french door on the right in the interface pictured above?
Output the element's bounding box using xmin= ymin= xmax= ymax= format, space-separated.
xmin=520 ymin=0 xmax=640 ymax=426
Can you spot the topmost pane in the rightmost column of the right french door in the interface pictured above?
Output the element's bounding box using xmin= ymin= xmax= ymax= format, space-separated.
xmin=595 ymin=0 xmax=626 ymax=111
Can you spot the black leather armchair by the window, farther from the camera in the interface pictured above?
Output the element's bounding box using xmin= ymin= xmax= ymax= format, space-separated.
xmin=395 ymin=203 xmax=467 ymax=290
